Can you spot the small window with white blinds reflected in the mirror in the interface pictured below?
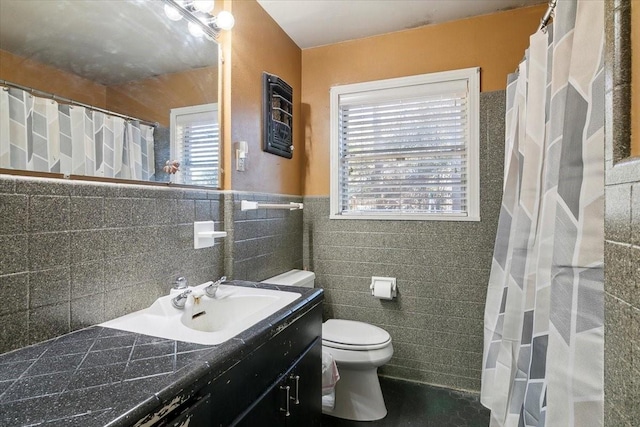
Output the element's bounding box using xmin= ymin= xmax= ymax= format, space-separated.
xmin=171 ymin=104 xmax=220 ymax=187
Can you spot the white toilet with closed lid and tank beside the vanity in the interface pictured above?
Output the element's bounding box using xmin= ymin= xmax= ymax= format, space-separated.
xmin=263 ymin=270 xmax=393 ymax=421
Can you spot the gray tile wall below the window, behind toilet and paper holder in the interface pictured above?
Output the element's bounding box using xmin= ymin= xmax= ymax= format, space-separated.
xmin=304 ymin=91 xmax=505 ymax=391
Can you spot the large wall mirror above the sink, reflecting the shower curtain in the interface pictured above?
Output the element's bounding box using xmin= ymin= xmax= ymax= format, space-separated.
xmin=0 ymin=0 xmax=219 ymax=187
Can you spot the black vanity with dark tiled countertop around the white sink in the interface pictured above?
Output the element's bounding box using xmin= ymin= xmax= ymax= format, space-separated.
xmin=0 ymin=281 xmax=323 ymax=427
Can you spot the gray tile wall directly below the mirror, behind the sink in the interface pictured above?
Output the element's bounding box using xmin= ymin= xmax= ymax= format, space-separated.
xmin=0 ymin=175 xmax=224 ymax=353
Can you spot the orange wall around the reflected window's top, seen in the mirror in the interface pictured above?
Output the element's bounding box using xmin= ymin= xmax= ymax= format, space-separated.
xmin=107 ymin=66 xmax=218 ymax=127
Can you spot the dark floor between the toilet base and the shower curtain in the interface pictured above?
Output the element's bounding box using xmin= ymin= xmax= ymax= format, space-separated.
xmin=322 ymin=378 xmax=489 ymax=427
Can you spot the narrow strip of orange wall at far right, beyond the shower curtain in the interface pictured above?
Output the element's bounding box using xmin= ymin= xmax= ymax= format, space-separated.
xmin=631 ymin=1 xmax=640 ymax=156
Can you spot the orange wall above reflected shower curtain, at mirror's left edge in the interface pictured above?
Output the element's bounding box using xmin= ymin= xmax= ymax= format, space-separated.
xmin=0 ymin=50 xmax=106 ymax=108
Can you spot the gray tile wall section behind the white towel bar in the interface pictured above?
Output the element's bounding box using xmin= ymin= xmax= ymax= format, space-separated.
xmin=225 ymin=192 xmax=303 ymax=281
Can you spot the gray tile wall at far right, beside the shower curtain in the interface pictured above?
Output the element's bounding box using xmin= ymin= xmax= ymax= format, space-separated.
xmin=604 ymin=0 xmax=640 ymax=427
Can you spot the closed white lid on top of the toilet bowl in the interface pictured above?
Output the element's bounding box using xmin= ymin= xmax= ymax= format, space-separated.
xmin=322 ymin=319 xmax=391 ymax=350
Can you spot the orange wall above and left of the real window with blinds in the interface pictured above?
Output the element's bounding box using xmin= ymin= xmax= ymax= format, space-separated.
xmin=302 ymin=4 xmax=547 ymax=195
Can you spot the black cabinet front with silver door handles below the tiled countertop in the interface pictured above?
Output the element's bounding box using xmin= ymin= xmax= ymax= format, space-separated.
xmin=158 ymin=304 xmax=322 ymax=427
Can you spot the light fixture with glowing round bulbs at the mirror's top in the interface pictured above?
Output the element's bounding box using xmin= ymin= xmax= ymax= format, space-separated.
xmin=163 ymin=0 xmax=235 ymax=39
